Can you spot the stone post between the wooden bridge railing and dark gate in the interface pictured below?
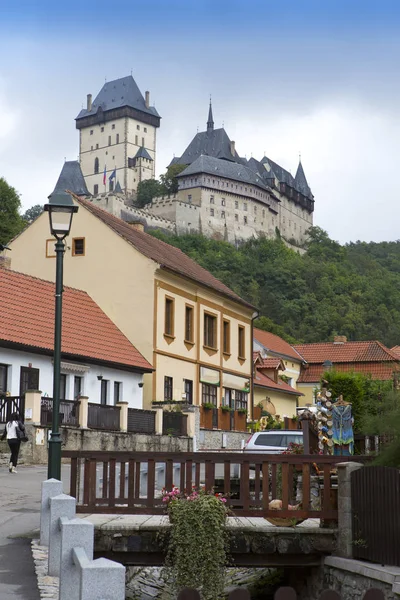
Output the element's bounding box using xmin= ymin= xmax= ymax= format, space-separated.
xmin=336 ymin=462 xmax=363 ymax=558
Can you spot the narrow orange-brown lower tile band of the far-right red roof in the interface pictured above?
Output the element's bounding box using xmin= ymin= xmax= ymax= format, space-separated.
xmin=297 ymin=361 xmax=400 ymax=383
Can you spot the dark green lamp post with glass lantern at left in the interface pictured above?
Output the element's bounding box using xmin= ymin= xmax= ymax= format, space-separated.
xmin=44 ymin=193 xmax=78 ymax=480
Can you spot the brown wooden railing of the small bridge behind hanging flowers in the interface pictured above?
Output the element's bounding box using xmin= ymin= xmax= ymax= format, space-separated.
xmin=63 ymin=451 xmax=362 ymax=520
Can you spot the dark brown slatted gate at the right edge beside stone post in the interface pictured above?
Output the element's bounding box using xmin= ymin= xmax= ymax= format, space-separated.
xmin=351 ymin=467 xmax=400 ymax=567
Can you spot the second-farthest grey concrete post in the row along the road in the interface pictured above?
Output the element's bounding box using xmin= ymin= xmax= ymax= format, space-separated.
xmin=49 ymin=494 xmax=76 ymax=577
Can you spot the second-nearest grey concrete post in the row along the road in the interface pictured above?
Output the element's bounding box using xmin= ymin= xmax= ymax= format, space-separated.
xmin=59 ymin=517 xmax=94 ymax=600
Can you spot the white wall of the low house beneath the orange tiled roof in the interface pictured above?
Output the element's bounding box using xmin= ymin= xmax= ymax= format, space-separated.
xmin=0 ymin=348 xmax=143 ymax=408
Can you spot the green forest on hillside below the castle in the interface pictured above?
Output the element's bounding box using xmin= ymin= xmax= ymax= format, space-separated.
xmin=153 ymin=227 xmax=400 ymax=348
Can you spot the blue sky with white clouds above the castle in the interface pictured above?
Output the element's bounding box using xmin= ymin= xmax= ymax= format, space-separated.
xmin=0 ymin=0 xmax=400 ymax=242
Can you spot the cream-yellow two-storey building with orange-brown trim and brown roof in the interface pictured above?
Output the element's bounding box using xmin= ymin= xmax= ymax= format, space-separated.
xmin=10 ymin=195 xmax=254 ymax=427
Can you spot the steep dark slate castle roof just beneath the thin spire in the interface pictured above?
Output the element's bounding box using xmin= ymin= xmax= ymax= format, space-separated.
xmin=171 ymin=127 xmax=242 ymax=165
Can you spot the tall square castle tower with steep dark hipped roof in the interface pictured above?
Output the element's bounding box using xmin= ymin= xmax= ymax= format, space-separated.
xmin=75 ymin=75 xmax=161 ymax=198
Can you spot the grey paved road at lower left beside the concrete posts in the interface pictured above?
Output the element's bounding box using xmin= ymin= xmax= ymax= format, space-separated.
xmin=0 ymin=466 xmax=69 ymax=600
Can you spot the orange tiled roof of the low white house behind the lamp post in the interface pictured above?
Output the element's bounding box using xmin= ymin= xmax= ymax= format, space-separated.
xmin=0 ymin=268 xmax=152 ymax=371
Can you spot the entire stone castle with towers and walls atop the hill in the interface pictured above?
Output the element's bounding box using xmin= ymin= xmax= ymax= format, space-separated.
xmin=53 ymin=76 xmax=314 ymax=246
